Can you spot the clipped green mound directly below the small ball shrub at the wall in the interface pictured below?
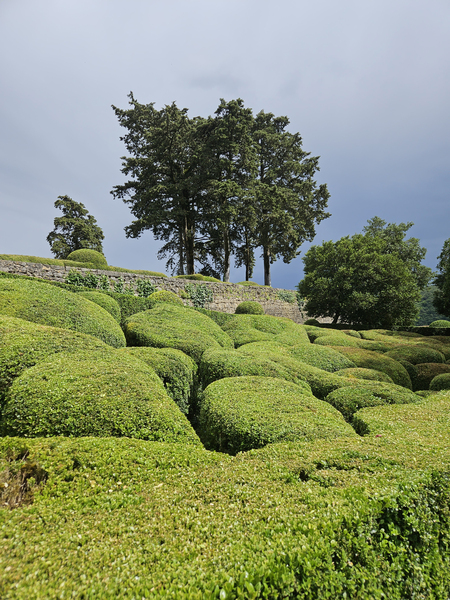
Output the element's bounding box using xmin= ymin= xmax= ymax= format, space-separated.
xmin=222 ymin=315 xmax=309 ymax=347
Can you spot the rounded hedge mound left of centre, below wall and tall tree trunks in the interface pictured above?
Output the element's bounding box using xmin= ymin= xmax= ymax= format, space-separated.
xmin=124 ymin=302 xmax=233 ymax=363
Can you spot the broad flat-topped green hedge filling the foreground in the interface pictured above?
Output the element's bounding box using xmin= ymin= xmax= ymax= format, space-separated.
xmin=0 ymin=437 xmax=450 ymax=600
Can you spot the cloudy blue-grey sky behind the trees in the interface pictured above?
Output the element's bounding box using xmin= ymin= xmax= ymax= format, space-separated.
xmin=0 ymin=0 xmax=450 ymax=289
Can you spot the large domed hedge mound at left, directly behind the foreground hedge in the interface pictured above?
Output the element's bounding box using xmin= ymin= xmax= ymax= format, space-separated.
xmin=0 ymin=350 xmax=198 ymax=444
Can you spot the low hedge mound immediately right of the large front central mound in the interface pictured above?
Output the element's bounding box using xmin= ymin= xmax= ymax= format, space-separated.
xmin=325 ymin=381 xmax=421 ymax=421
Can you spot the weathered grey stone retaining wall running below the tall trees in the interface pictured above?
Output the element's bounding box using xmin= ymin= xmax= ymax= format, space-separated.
xmin=0 ymin=260 xmax=307 ymax=323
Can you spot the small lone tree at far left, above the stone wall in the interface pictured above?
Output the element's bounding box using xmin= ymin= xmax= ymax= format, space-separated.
xmin=47 ymin=196 xmax=106 ymax=263
